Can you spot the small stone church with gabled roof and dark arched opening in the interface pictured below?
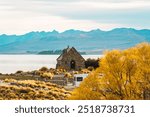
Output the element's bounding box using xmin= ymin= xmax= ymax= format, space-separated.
xmin=56 ymin=47 xmax=85 ymax=70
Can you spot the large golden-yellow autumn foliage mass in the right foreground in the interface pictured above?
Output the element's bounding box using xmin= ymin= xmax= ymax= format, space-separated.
xmin=69 ymin=43 xmax=150 ymax=100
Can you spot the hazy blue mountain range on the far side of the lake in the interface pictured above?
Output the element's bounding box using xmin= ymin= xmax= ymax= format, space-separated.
xmin=0 ymin=28 xmax=150 ymax=54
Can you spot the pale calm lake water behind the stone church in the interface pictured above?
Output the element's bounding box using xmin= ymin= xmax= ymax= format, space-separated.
xmin=0 ymin=55 xmax=102 ymax=73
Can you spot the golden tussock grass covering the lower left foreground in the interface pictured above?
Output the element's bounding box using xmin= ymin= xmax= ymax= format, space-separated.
xmin=0 ymin=79 xmax=70 ymax=100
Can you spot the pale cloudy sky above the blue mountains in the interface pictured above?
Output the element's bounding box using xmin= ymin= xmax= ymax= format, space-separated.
xmin=0 ymin=0 xmax=150 ymax=34
